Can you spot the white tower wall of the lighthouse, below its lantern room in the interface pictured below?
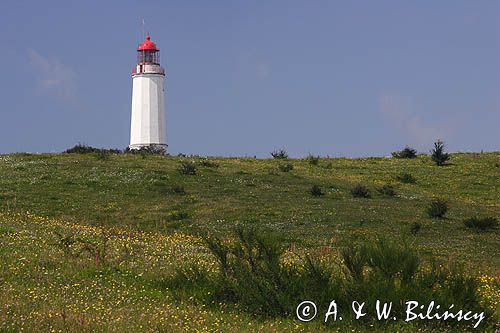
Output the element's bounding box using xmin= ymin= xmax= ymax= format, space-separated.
xmin=129 ymin=73 xmax=167 ymax=149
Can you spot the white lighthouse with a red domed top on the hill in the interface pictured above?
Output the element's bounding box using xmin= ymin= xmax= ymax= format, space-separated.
xmin=129 ymin=36 xmax=167 ymax=152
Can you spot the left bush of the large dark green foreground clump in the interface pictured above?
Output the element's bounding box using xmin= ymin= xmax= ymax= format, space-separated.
xmin=197 ymin=228 xmax=339 ymax=317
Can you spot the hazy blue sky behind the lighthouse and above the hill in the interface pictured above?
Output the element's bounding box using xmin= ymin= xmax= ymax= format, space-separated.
xmin=0 ymin=0 xmax=500 ymax=156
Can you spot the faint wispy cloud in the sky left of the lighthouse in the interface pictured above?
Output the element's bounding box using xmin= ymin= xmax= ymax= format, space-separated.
xmin=28 ymin=50 xmax=76 ymax=103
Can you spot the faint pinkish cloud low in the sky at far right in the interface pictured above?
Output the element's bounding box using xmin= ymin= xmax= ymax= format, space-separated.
xmin=380 ymin=94 xmax=453 ymax=145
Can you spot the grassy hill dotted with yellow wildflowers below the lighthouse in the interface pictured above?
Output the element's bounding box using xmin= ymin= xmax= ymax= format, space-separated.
xmin=0 ymin=153 xmax=500 ymax=332
